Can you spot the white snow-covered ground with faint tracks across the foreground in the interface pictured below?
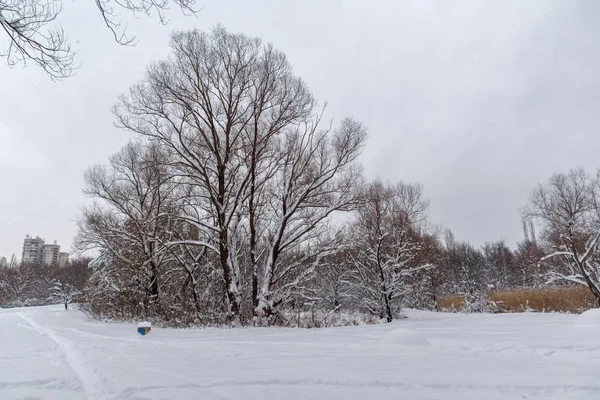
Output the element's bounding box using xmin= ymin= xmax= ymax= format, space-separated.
xmin=0 ymin=306 xmax=600 ymax=400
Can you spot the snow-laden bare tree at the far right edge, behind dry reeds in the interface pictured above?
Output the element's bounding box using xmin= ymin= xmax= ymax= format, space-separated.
xmin=524 ymin=169 xmax=600 ymax=303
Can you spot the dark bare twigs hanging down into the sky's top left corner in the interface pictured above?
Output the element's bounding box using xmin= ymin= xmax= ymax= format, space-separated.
xmin=0 ymin=0 xmax=198 ymax=79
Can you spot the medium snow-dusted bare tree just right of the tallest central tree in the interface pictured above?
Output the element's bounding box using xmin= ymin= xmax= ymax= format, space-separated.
xmin=351 ymin=181 xmax=431 ymax=322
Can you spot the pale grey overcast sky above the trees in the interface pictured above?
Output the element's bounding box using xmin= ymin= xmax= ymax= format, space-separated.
xmin=0 ymin=0 xmax=600 ymax=257
